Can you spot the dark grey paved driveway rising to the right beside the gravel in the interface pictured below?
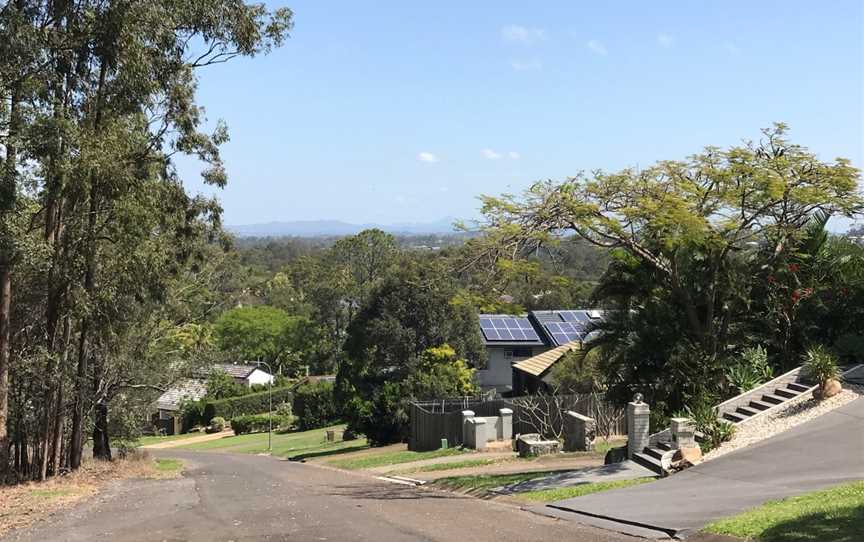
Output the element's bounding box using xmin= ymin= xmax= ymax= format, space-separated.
xmin=544 ymin=399 xmax=864 ymax=538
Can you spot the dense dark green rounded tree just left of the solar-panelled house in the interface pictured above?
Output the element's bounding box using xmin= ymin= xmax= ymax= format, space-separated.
xmin=337 ymin=261 xmax=484 ymax=444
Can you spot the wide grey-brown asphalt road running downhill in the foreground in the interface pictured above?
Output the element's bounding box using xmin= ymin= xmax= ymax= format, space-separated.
xmin=4 ymin=450 xmax=635 ymax=542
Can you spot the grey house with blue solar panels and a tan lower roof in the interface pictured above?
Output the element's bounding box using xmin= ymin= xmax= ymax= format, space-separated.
xmin=477 ymin=310 xmax=603 ymax=394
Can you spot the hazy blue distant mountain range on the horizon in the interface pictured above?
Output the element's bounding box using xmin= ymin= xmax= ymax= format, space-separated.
xmin=226 ymin=218 xmax=456 ymax=237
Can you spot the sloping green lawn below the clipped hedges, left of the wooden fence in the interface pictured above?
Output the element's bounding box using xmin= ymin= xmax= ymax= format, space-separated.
xmin=177 ymin=425 xmax=369 ymax=459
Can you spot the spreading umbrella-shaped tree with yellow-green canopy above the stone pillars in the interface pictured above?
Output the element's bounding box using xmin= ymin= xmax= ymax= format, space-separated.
xmin=475 ymin=124 xmax=862 ymax=414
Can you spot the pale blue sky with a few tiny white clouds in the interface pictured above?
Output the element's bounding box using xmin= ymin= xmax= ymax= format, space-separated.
xmin=178 ymin=0 xmax=864 ymax=230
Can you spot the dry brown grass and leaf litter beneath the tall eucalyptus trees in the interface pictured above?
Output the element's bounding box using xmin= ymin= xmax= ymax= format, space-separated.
xmin=0 ymin=453 xmax=180 ymax=536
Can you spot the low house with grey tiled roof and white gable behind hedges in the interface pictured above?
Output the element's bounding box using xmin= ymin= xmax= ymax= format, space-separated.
xmin=153 ymin=363 xmax=273 ymax=435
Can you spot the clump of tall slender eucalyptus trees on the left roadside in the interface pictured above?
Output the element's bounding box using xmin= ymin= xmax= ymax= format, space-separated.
xmin=0 ymin=0 xmax=292 ymax=484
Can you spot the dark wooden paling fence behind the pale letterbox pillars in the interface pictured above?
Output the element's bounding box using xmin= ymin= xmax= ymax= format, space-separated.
xmin=408 ymin=394 xmax=627 ymax=452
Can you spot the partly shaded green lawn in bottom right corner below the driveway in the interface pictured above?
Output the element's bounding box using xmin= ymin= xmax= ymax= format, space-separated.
xmin=704 ymin=481 xmax=864 ymax=542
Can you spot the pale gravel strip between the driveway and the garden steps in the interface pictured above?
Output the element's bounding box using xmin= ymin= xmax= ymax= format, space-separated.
xmin=702 ymin=384 xmax=864 ymax=461
